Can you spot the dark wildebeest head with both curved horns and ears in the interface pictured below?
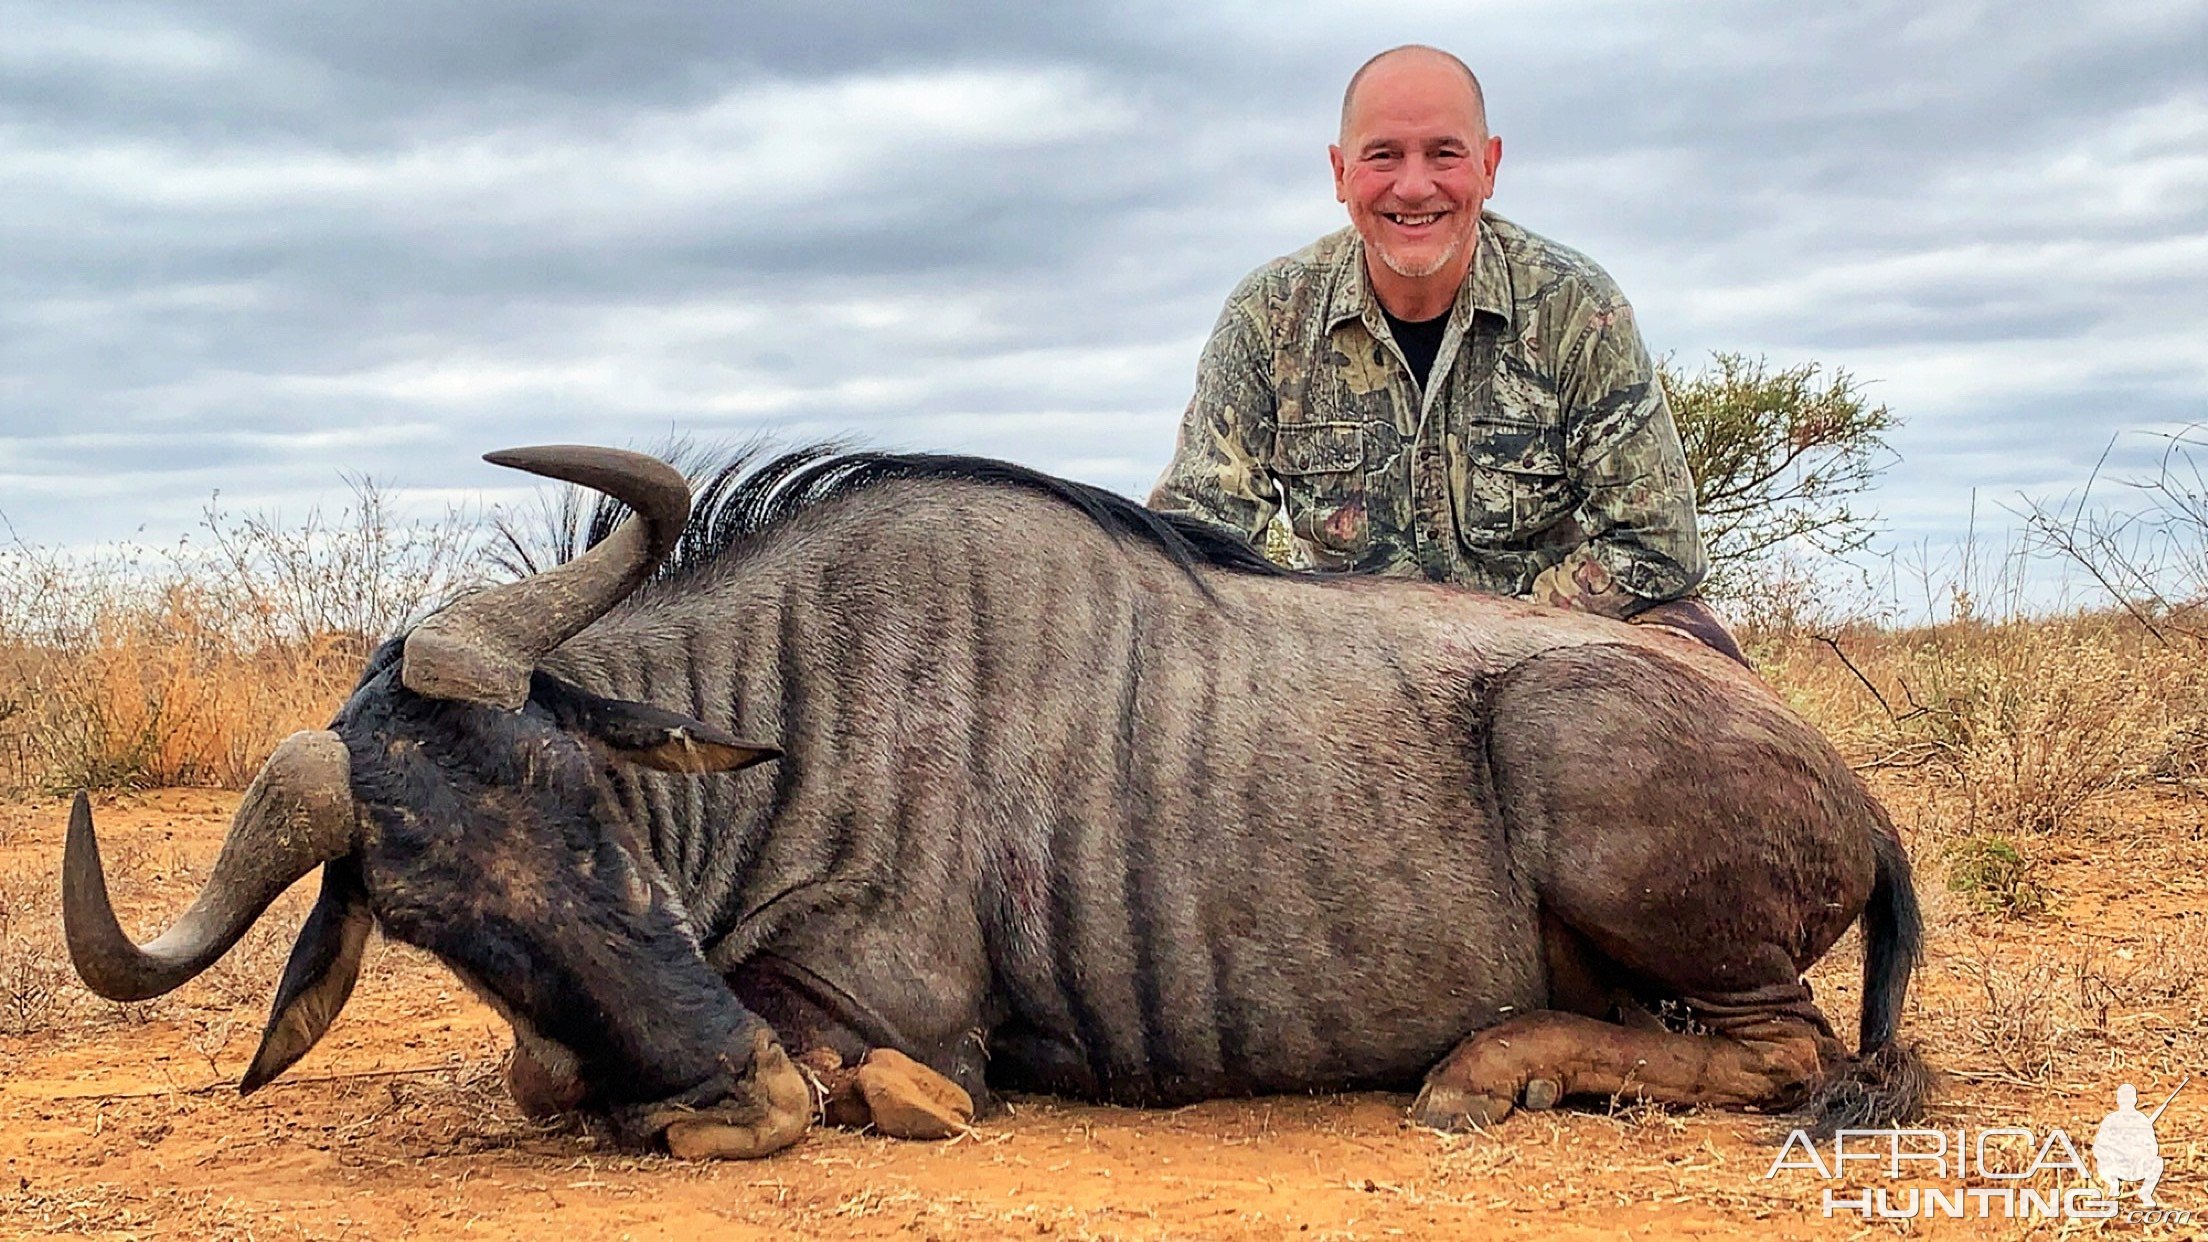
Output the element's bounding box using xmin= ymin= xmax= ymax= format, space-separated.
xmin=62 ymin=446 xmax=810 ymax=1156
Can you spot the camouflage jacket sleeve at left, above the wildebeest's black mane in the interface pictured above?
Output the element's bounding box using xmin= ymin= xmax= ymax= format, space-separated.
xmin=1150 ymin=283 xmax=1278 ymax=541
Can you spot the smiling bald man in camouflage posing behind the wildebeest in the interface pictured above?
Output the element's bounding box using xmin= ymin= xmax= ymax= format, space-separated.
xmin=1150 ymin=46 xmax=1738 ymax=659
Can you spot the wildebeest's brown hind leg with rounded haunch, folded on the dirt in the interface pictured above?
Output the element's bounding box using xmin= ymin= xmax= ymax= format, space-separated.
xmin=1413 ymin=648 xmax=1877 ymax=1127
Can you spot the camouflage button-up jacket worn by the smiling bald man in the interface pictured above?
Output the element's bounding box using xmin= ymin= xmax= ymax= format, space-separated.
xmin=1150 ymin=212 xmax=1705 ymax=617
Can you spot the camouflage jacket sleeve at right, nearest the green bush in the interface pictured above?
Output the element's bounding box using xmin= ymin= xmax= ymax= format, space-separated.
xmin=1535 ymin=296 xmax=1709 ymax=617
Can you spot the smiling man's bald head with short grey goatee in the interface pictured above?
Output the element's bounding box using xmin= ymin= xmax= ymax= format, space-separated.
xmin=1327 ymin=44 xmax=1504 ymax=314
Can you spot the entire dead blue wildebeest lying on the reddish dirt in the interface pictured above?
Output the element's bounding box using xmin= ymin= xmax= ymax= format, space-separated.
xmin=64 ymin=446 xmax=1921 ymax=1156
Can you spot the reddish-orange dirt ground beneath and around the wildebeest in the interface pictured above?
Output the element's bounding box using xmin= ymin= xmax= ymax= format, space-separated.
xmin=0 ymin=789 xmax=2208 ymax=1240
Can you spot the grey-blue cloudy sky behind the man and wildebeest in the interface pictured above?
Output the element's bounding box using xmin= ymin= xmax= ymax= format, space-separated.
xmin=0 ymin=0 xmax=2208 ymax=596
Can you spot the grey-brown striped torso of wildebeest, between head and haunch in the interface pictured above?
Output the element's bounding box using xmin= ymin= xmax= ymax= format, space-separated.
xmin=545 ymin=482 xmax=1792 ymax=1101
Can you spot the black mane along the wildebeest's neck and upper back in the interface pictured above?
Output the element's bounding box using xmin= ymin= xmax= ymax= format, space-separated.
xmin=501 ymin=444 xmax=1289 ymax=583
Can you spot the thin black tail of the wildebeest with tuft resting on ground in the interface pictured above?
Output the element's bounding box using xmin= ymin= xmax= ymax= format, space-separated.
xmin=1804 ymin=804 xmax=1932 ymax=1138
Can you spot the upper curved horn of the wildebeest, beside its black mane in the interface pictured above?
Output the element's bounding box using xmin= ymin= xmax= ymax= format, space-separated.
xmin=400 ymin=444 xmax=691 ymax=709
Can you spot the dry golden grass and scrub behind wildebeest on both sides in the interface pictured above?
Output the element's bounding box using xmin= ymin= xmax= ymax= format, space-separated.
xmin=0 ymin=482 xmax=2208 ymax=817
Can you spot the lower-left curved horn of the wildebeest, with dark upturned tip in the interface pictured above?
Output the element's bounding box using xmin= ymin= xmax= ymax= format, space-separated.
xmin=62 ymin=729 xmax=353 ymax=1001
